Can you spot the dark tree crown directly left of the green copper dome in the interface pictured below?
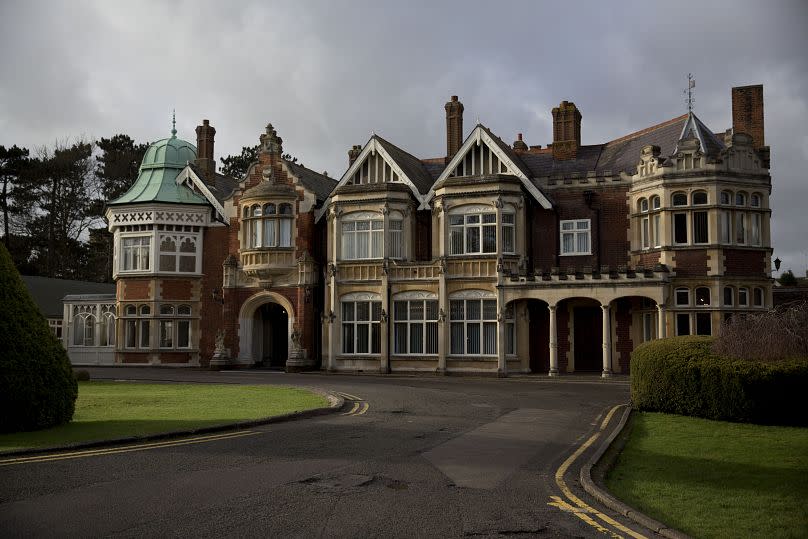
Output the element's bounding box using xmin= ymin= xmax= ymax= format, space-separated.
xmin=95 ymin=134 xmax=149 ymax=201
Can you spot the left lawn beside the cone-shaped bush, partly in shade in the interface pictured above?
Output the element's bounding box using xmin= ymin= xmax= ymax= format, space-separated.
xmin=0 ymin=382 xmax=328 ymax=451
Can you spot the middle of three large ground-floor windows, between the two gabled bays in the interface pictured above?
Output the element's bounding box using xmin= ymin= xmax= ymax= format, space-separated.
xmin=393 ymin=292 xmax=438 ymax=355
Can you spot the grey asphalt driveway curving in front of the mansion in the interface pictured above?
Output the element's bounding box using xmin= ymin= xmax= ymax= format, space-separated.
xmin=0 ymin=369 xmax=651 ymax=538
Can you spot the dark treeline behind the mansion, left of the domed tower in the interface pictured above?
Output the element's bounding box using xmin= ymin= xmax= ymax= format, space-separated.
xmin=0 ymin=134 xmax=148 ymax=282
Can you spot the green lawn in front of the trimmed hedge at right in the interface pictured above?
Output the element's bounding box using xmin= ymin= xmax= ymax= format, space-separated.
xmin=606 ymin=413 xmax=808 ymax=538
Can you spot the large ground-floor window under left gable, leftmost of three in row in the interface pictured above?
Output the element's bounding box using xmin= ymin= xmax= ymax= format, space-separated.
xmin=342 ymin=294 xmax=382 ymax=354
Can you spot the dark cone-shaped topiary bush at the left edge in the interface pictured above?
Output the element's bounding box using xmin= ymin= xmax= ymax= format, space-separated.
xmin=0 ymin=244 xmax=78 ymax=432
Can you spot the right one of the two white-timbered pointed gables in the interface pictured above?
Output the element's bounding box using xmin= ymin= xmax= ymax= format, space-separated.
xmin=421 ymin=125 xmax=552 ymax=209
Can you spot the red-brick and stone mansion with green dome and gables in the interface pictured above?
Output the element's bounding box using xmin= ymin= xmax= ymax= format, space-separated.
xmin=64 ymin=86 xmax=772 ymax=377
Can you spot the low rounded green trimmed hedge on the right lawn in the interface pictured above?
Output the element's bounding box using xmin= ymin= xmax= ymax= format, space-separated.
xmin=631 ymin=336 xmax=808 ymax=425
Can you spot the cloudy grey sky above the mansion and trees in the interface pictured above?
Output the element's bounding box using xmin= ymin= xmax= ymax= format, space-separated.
xmin=0 ymin=0 xmax=808 ymax=275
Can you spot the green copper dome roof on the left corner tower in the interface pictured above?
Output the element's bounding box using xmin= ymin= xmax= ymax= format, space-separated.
xmin=108 ymin=125 xmax=208 ymax=205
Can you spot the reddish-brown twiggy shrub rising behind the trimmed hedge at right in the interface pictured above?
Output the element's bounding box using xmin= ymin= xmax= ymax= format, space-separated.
xmin=713 ymin=302 xmax=808 ymax=361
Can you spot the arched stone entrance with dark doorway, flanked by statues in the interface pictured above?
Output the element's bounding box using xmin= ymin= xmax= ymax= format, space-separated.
xmin=238 ymin=290 xmax=295 ymax=367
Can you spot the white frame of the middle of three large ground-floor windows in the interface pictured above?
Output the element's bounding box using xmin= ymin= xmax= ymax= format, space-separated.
xmin=393 ymin=292 xmax=440 ymax=356
